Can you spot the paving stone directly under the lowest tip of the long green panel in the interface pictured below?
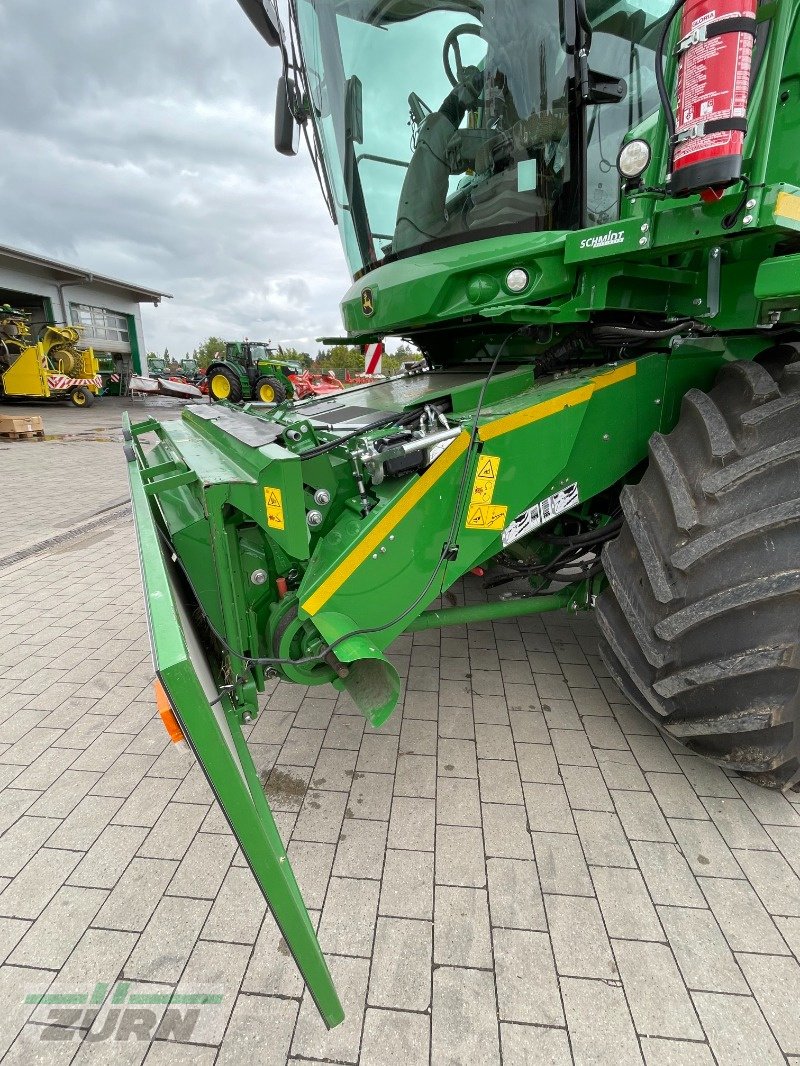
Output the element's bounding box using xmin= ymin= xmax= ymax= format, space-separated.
xmin=291 ymin=955 xmax=369 ymax=1063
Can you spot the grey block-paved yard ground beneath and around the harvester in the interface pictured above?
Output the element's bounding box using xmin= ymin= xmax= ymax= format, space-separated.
xmin=0 ymin=400 xmax=800 ymax=1066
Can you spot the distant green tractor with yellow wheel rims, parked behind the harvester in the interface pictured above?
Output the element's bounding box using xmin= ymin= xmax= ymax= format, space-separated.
xmin=207 ymin=340 xmax=302 ymax=404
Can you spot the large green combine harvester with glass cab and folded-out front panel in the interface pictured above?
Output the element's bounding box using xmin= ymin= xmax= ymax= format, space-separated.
xmin=127 ymin=0 xmax=800 ymax=1025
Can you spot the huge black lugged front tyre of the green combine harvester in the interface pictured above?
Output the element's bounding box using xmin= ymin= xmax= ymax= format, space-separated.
xmin=597 ymin=345 xmax=800 ymax=789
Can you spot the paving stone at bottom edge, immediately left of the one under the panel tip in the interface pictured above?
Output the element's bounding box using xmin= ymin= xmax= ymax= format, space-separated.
xmin=217 ymin=996 xmax=299 ymax=1066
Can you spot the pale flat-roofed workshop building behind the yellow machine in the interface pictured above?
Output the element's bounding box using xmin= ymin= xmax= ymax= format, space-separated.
xmin=0 ymin=244 xmax=170 ymax=374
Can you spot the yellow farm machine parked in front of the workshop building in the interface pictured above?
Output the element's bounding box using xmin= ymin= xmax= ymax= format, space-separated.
xmin=0 ymin=306 xmax=102 ymax=407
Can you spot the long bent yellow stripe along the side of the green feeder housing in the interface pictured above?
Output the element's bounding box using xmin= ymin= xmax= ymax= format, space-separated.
xmin=301 ymin=362 xmax=636 ymax=615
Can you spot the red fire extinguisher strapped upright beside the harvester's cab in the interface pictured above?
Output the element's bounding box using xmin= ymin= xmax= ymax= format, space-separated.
xmin=672 ymin=0 xmax=756 ymax=195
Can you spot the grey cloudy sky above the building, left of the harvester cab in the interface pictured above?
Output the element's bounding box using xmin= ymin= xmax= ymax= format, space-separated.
xmin=0 ymin=0 xmax=350 ymax=355
